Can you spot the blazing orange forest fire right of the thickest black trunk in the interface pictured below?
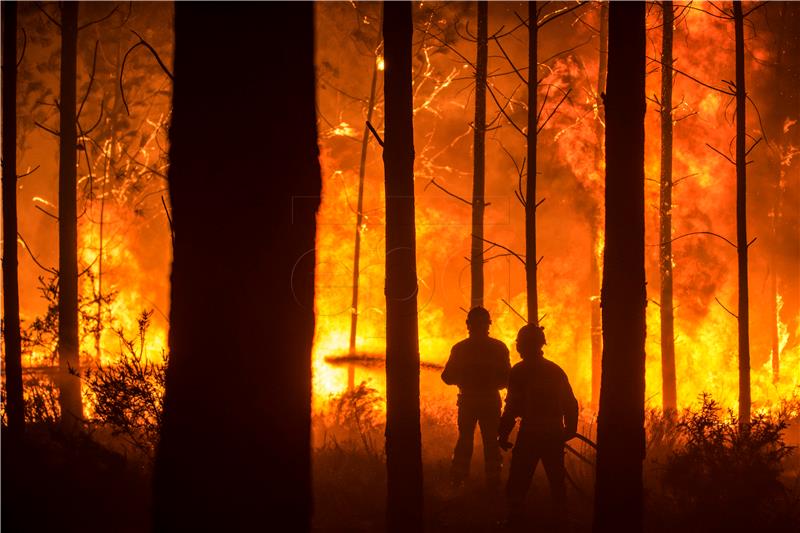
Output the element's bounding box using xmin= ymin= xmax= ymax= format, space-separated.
xmin=314 ymin=0 xmax=800 ymax=409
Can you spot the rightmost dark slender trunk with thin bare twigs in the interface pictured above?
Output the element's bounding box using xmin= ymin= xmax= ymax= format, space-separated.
xmin=733 ymin=0 xmax=750 ymax=424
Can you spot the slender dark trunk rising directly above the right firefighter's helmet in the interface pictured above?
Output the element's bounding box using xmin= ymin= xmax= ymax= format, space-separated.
xmin=525 ymin=2 xmax=539 ymax=324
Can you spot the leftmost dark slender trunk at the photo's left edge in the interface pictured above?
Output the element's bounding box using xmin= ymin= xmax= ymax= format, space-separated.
xmin=2 ymin=2 xmax=25 ymax=436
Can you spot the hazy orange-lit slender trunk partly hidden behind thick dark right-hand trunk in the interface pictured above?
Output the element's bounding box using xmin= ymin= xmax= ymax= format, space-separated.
xmin=589 ymin=2 xmax=608 ymax=409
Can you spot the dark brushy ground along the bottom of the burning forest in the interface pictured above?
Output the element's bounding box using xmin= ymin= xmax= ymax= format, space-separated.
xmin=1 ymin=409 xmax=800 ymax=533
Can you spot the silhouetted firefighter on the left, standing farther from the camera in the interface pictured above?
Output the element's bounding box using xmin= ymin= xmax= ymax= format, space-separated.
xmin=442 ymin=307 xmax=511 ymax=487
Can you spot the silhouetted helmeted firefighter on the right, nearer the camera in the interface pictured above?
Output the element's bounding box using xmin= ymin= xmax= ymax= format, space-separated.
xmin=498 ymin=324 xmax=578 ymax=525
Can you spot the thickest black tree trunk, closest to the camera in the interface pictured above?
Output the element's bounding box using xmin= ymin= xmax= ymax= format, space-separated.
xmin=153 ymin=2 xmax=321 ymax=531
